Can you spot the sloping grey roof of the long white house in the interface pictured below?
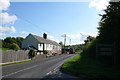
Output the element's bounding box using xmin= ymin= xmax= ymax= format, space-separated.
xmin=29 ymin=34 xmax=60 ymax=46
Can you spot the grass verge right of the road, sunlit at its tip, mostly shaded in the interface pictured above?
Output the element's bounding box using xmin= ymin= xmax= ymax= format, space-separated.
xmin=61 ymin=53 xmax=120 ymax=80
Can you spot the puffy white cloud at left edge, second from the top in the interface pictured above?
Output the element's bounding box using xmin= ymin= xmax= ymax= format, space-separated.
xmin=0 ymin=12 xmax=17 ymax=24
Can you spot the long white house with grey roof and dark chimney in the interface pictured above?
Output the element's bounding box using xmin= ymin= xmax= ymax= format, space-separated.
xmin=22 ymin=33 xmax=61 ymax=53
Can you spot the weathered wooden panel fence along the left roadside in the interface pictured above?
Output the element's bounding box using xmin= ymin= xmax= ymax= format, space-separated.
xmin=1 ymin=50 xmax=29 ymax=63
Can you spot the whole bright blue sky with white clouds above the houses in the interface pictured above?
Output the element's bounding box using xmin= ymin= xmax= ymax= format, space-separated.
xmin=0 ymin=0 xmax=109 ymax=45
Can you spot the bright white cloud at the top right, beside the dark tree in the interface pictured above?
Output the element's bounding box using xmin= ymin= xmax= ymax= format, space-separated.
xmin=89 ymin=0 xmax=109 ymax=11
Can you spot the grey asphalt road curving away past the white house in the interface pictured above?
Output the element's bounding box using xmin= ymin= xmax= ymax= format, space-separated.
xmin=2 ymin=54 xmax=84 ymax=79
